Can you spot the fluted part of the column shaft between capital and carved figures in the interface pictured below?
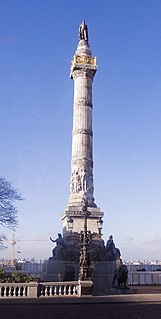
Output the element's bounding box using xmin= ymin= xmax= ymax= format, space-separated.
xmin=71 ymin=77 xmax=93 ymax=161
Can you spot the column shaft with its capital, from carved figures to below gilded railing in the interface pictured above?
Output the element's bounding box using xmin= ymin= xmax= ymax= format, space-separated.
xmin=69 ymin=63 xmax=96 ymax=207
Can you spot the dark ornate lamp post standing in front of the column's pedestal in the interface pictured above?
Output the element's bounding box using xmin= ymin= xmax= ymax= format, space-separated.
xmin=79 ymin=200 xmax=91 ymax=280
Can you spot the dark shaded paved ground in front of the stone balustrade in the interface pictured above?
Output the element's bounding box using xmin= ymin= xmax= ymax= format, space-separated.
xmin=0 ymin=294 xmax=161 ymax=319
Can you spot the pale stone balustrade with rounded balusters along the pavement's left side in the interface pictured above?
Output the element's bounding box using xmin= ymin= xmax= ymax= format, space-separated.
xmin=0 ymin=281 xmax=87 ymax=299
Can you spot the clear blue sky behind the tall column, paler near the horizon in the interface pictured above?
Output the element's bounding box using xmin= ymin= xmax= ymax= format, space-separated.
xmin=0 ymin=0 xmax=161 ymax=260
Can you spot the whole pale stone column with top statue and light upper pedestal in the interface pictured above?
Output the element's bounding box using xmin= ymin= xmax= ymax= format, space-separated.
xmin=62 ymin=21 xmax=103 ymax=235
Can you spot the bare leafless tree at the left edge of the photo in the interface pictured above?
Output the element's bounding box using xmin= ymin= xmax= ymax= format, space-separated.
xmin=0 ymin=177 xmax=23 ymax=249
